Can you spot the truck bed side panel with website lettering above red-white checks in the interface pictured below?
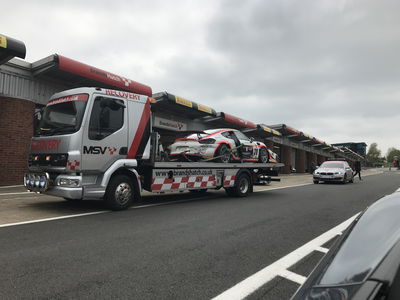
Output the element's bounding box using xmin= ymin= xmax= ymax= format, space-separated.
xmin=150 ymin=169 xmax=239 ymax=192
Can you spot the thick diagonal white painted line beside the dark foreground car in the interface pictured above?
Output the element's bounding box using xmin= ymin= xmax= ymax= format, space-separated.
xmin=213 ymin=213 xmax=358 ymax=300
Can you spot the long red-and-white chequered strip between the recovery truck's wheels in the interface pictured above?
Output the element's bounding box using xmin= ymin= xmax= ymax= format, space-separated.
xmin=151 ymin=175 xmax=217 ymax=191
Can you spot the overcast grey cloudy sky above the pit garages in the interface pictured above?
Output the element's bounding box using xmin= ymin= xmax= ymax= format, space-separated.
xmin=0 ymin=0 xmax=400 ymax=154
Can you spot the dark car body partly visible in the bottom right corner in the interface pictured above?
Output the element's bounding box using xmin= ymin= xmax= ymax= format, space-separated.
xmin=292 ymin=192 xmax=400 ymax=300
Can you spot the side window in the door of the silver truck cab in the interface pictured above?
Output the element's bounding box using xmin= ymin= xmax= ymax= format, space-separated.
xmin=89 ymin=97 xmax=125 ymax=140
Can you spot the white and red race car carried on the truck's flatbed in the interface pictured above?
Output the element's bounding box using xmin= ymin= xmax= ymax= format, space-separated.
xmin=169 ymin=128 xmax=278 ymax=163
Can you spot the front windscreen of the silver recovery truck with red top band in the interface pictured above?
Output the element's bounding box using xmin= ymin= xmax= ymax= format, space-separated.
xmin=35 ymin=94 xmax=89 ymax=136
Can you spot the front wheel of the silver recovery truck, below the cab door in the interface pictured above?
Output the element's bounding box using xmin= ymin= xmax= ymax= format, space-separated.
xmin=104 ymin=175 xmax=134 ymax=210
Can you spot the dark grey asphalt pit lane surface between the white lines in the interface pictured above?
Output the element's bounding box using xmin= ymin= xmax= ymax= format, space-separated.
xmin=0 ymin=172 xmax=400 ymax=299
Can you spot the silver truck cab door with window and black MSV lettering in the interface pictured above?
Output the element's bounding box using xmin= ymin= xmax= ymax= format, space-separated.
xmin=82 ymin=95 xmax=128 ymax=173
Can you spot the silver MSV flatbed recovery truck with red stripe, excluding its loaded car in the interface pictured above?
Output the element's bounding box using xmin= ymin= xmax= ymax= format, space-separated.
xmin=24 ymin=88 xmax=283 ymax=210
